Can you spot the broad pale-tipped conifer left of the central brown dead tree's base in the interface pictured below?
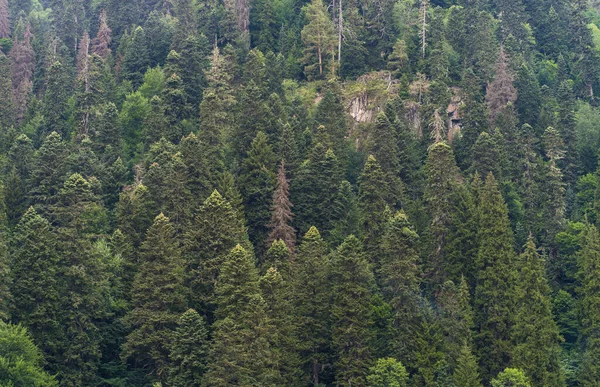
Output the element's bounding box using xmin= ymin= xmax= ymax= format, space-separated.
xmin=183 ymin=191 xmax=247 ymax=316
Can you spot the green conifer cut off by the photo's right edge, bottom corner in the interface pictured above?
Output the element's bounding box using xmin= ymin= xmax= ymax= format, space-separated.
xmin=579 ymin=225 xmax=600 ymax=387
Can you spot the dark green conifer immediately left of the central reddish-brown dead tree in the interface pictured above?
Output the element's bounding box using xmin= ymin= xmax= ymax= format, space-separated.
xmin=240 ymin=132 xmax=276 ymax=255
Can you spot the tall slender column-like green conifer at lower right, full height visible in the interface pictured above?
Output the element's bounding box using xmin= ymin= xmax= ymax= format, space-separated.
xmin=474 ymin=174 xmax=517 ymax=380
